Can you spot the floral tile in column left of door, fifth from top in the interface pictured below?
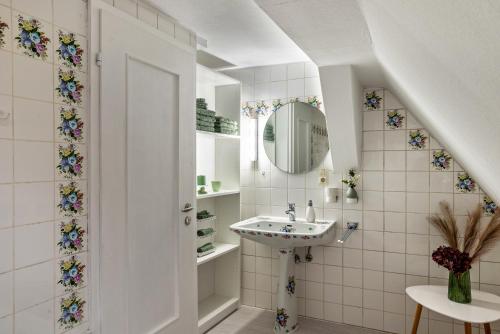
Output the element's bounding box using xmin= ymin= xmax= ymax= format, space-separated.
xmin=55 ymin=181 xmax=87 ymax=219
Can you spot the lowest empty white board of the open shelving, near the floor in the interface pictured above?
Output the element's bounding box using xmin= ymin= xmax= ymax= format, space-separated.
xmin=198 ymin=295 xmax=239 ymax=333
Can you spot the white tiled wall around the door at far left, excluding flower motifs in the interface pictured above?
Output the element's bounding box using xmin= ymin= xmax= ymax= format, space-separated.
xmin=0 ymin=0 xmax=196 ymax=334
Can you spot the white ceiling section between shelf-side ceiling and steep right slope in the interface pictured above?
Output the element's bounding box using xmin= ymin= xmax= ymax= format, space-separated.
xmin=255 ymin=0 xmax=386 ymax=86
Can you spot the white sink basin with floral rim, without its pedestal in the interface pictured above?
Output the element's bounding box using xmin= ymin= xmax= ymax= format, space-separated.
xmin=230 ymin=217 xmax=335 ymax=248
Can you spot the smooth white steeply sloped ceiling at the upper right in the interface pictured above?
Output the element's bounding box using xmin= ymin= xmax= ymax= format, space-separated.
xmin=360 ymin=0 xmax=500 ymax=202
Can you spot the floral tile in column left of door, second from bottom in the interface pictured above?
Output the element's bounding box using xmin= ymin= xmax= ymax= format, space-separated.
xmin=56 ymin=253 xmax=87 ymax=296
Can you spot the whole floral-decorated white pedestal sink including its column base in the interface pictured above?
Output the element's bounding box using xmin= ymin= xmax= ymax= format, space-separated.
xmin=230 ymin=217 xmax=335 ymax=334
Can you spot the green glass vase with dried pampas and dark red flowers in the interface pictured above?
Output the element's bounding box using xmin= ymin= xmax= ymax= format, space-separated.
xmin=428 ymin=202 xmax=500 ymax=304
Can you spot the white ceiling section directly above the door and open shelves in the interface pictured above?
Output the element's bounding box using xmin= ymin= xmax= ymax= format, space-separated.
xmin=143 ymin=0 xmax=309 ymax=67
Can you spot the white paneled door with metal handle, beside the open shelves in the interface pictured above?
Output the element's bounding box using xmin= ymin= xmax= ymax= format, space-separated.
xmin=94 ymin=5 xmax=197 ymax=334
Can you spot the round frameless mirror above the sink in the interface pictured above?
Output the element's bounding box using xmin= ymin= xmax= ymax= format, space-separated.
xmin=263 ymin=102 xmax=329 ymax=174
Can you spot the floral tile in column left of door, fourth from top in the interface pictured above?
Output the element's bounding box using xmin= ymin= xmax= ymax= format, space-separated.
xmin=54 ymin=143 xmax=87 ymax=180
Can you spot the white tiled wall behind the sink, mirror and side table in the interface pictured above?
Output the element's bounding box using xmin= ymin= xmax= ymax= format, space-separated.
xmin=228 ymin=63 xmax=500 ymax=334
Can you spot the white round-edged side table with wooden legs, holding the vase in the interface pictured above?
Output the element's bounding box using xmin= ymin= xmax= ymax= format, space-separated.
xmin=406 ymin=285 xmax=500 ymax=334
